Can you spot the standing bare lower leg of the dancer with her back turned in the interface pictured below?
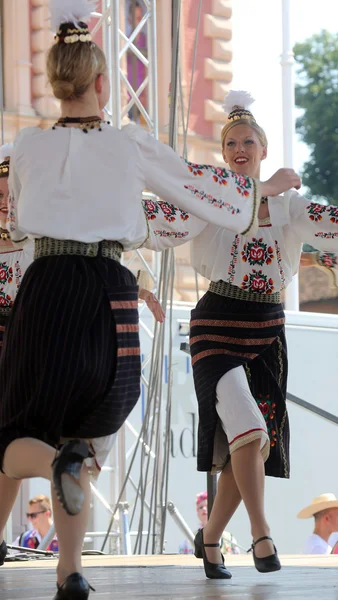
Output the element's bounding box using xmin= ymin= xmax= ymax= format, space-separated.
xmin=52 ymin=467 xmax=90 ymax=584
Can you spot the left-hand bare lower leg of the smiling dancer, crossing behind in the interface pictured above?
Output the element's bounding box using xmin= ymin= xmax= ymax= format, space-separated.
xmin=203 ymin=463 xmax=241 ymax=564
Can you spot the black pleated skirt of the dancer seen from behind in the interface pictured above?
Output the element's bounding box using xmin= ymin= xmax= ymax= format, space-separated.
xmin=0 ymin=256 xmax=141 ymax=467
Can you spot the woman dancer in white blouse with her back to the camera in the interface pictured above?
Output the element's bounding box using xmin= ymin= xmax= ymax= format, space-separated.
xmin=0 ymin=0 xmax=299 ymax=600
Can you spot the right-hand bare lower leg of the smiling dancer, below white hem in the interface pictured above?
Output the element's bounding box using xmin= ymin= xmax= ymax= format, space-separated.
xmin=231 ymin=440 xmax=274 ymax=557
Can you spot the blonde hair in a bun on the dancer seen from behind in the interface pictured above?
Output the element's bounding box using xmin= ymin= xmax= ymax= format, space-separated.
xmin=47 ymin=42 xmax=107 ymax=100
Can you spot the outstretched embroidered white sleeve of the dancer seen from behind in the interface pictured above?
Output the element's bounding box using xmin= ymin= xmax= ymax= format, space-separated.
xmin=123 ymin=125 xmax=260 ymax=234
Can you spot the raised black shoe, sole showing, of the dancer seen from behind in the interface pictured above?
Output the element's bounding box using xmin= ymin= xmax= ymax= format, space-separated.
xmin=52 ymin=440 xmax=89 ymax=515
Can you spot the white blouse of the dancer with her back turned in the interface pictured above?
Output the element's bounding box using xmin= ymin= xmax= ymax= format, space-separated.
xmin=8 ymin=125 xmax=259 ymax=250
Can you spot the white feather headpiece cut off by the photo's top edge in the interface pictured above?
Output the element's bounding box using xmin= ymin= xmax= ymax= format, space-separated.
xmin=49 ymin=0 xmax=97 ymax=31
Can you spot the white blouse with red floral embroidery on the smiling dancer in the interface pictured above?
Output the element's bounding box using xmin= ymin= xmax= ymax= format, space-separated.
xmin=144 ymin=191 xmax=338 ymax=294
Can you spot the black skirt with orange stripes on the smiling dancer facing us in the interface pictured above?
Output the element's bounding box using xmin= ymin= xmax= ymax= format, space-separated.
xmin=190 ymin=292 xmax=290 ymax=478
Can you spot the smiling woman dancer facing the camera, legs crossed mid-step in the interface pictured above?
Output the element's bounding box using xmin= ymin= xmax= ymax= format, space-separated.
xmin=186 ymin=92 xmax=338 ymax=578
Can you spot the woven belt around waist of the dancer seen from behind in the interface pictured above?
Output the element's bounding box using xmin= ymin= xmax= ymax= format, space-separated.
xmin=34 ymin=237 xmax=123 ymax=262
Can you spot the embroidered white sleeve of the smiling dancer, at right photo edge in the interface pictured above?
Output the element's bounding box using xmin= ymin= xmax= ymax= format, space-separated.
xmin=269 ymin=191 xmax=338 ymax=252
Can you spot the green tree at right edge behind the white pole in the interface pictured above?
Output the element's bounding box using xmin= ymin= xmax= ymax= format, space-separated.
xmin=294 ymin=30 xmax=338 ymax=204
